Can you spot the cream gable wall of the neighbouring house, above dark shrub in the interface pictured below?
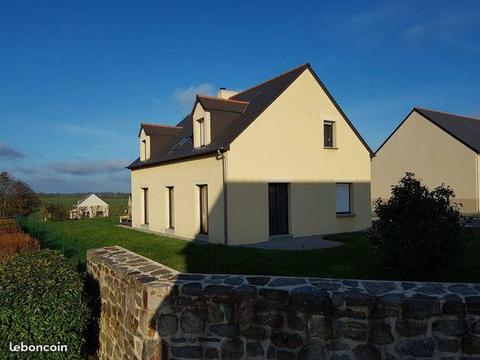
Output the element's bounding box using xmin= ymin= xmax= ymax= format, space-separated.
xmin=372 ymin=111 xmax=479 ymax=212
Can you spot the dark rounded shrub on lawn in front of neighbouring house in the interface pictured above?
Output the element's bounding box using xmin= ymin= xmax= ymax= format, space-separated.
xmin=369 ymin=173 xmax=465 ymax=277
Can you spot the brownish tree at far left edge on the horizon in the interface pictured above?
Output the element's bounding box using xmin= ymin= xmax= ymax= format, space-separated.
xmin=0 ymin=171 xmax=41 ymax=218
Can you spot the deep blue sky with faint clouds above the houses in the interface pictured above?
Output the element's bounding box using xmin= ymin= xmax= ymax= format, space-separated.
xmin=0 ymin=0 xmax=480 ymax=192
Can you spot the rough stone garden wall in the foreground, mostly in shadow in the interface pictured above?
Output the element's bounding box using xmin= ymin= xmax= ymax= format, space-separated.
xmin=87 ymin=246 xmax=480 ymax=360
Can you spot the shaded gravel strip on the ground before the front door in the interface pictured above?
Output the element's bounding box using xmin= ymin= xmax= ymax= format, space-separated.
xmin=242 ymin=235 xmax=344 ymax=250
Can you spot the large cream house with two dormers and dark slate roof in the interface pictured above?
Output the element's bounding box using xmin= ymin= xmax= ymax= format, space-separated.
xmin=128 ymin=64 xmax=371 ymax=245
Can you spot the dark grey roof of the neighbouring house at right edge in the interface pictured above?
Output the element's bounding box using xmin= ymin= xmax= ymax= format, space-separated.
xmin=375 ymin=107 xmax=480 ymax=154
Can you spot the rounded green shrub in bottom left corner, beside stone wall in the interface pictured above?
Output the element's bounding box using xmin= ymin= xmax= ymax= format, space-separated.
xmin=0 ymin=250 xmax=89 ymax=359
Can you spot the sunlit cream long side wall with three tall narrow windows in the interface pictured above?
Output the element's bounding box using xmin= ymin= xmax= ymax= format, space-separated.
xmin=131 ymin=156 xmax=224 ymax=243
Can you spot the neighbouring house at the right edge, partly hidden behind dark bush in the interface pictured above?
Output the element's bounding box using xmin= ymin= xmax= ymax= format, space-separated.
xmin=372 ymin=108 xmax=480 ymax=213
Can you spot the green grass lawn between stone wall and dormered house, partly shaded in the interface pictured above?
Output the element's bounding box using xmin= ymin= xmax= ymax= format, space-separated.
xmin=18 ymin=218 xmax=480 ymax=282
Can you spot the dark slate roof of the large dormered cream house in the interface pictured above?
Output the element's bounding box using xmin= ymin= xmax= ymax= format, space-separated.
xmin=128 ymin=64 xmax=372 ymax=169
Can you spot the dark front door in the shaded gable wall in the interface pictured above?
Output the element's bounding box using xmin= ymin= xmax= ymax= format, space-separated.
xmin=268 ymin=183 xmax=288 ymax=235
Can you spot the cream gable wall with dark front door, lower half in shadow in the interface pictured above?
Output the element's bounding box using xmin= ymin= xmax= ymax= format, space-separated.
xmin=227 ymin=70 xmax=370 ymax=244
